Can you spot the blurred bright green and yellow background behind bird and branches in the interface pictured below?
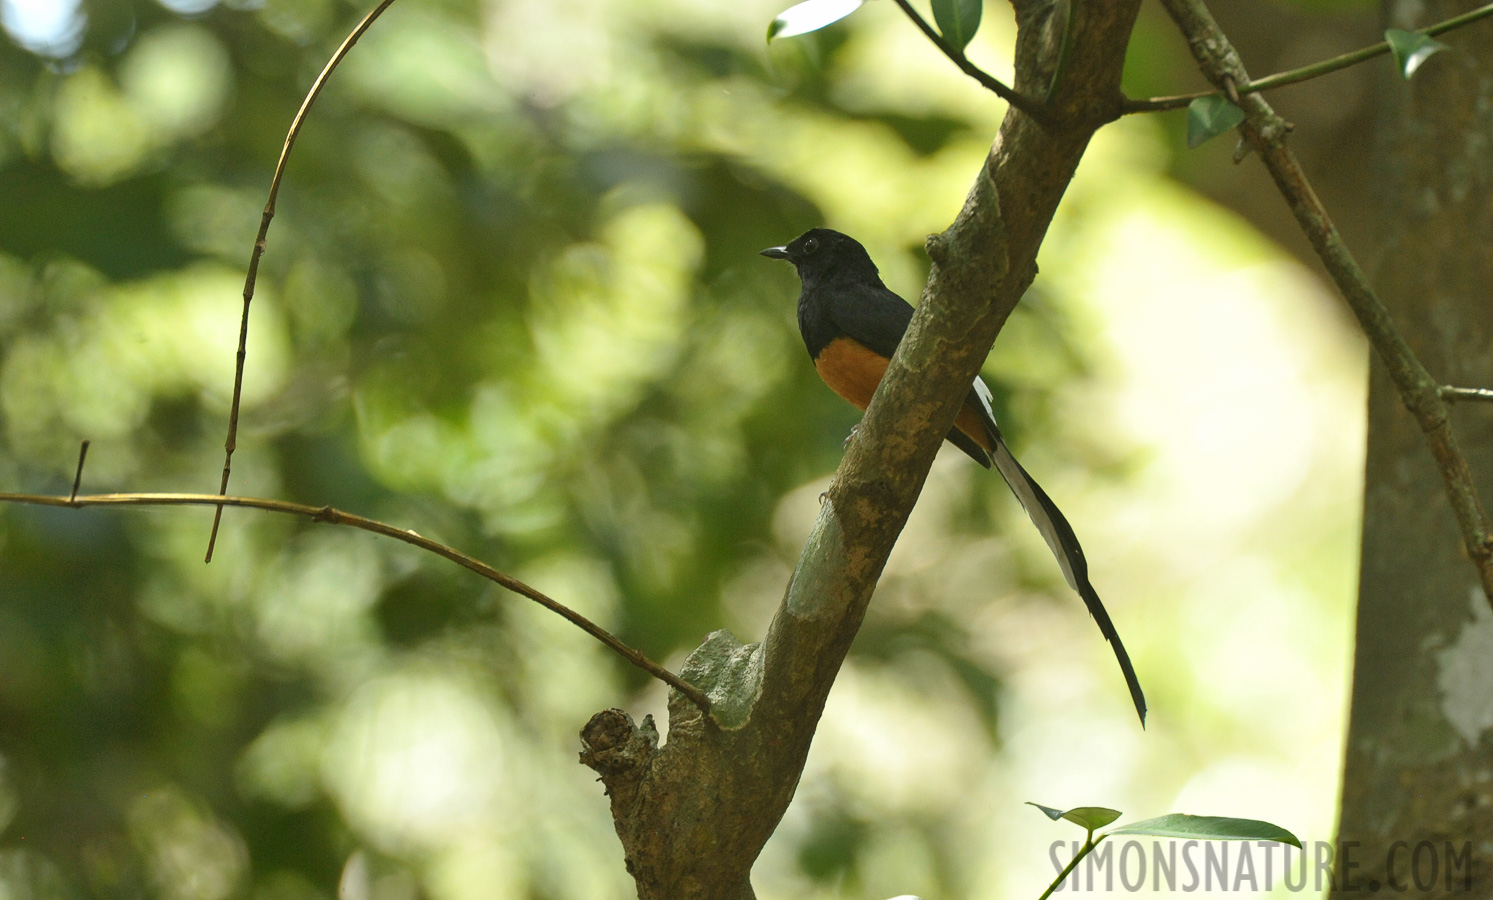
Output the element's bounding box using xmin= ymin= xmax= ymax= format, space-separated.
xmin=0 ymin=0 xmax=1387 ymax=900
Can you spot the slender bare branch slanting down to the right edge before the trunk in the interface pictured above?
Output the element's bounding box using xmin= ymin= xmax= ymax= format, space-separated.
xmin=1162 ymin=0 xmax=1493 ymax=604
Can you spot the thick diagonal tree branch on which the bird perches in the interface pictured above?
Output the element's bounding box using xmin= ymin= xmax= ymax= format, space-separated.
xmin=581 ymin=0 xmax=1139 ymax=900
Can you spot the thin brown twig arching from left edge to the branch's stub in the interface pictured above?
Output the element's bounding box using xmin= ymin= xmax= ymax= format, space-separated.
xmin=0 ymin=489 xmax=711 ymax=712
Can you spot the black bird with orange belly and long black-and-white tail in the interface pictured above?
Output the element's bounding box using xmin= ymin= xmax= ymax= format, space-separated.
xmin=761 ymin=228 xmax=1145 ymax=727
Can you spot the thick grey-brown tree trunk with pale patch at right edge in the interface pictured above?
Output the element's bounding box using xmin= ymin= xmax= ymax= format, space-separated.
xmin=1333 ymin=0 xmax=1493 ymax=897
